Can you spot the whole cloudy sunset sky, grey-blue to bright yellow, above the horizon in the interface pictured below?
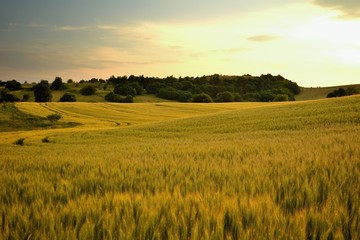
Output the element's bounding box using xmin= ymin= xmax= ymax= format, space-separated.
xmin=0 ymin=0 xmax=360 ymax=87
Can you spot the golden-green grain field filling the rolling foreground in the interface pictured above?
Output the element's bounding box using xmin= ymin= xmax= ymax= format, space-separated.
xmin=0 ymin=96 xmax=360 ymax=239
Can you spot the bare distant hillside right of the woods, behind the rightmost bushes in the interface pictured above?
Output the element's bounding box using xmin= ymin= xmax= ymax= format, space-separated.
xmin=295 ymin=84 xmax=360 ymax=101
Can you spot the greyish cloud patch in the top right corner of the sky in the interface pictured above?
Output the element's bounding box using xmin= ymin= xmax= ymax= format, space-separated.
xmin=313 ymin=0 xmax=360 ymax=18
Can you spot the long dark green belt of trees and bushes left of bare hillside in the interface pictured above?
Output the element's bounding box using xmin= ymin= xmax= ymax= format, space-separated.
xmin=0 ymin=74 xmax=300 ymax=103
